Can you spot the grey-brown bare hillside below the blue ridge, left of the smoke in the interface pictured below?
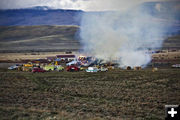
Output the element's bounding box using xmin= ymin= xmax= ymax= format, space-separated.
xmin=0 ymin=26 xmax=80 ymax=52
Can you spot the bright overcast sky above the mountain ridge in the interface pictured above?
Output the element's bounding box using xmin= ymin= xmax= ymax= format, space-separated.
xmin=0 ymin=0 xmax=176 ymax=11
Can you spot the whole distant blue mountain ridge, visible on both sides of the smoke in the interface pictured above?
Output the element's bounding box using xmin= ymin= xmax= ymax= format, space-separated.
xmin=0 ymin=1 xmax=180 ymax=26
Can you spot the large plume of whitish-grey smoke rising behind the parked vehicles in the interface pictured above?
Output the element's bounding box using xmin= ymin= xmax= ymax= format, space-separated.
xmin=80 ymin=3 xmax=169 ymax=67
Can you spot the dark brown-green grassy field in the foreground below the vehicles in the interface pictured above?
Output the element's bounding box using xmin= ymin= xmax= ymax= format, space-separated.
xmin=0 ymin=68 xmax=180 ymax=120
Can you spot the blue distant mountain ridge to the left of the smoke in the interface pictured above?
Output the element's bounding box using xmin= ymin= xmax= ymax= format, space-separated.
xmin=0 ymin=6 xmax=83 ymax=26
